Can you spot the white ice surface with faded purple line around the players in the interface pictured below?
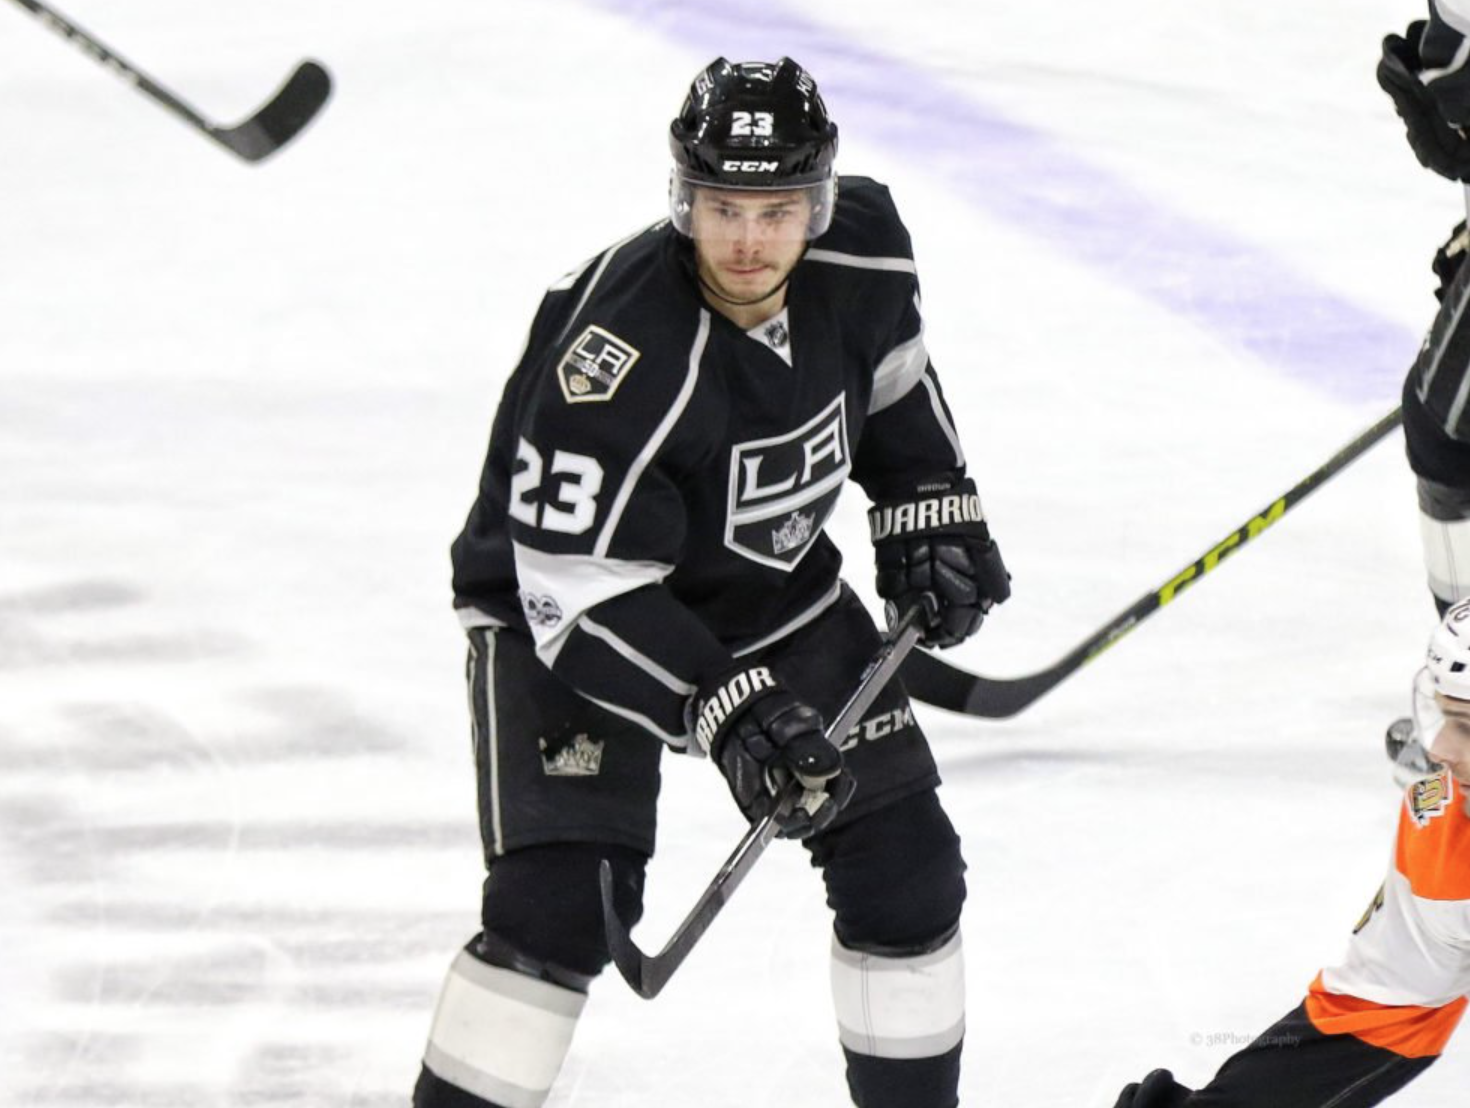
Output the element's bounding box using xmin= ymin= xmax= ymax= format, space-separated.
xmin=0 ymin=0 xmax=1470 ymax=1108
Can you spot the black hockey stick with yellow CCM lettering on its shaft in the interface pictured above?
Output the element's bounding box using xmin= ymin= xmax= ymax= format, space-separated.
xmin=900 ymin=409 xmax=1404 ymax=719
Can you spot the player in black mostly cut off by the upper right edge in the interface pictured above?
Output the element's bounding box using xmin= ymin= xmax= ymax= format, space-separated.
xmin=1377 ymin=0 xmax=1470 ymax=614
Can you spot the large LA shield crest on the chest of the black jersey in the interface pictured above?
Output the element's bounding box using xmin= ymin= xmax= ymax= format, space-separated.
xmin=725 ymin=394 xmax=853 ymax=570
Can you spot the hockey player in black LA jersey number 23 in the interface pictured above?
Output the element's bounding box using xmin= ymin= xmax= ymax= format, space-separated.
xmin=415 ymin=59 xmax=1010 ymax=1108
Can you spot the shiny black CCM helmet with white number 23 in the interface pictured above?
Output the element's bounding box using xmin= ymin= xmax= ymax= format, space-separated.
xmin=669 ymin=57 xmax=836 ymax=238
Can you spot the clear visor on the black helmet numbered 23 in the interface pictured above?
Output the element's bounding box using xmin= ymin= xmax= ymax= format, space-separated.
xmin=669 ymin=169 xmax=836 ymax=242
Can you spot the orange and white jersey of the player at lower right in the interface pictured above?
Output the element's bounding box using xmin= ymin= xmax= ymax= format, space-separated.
xmin=1305 ymin=773 xmax=1470 ymax=1058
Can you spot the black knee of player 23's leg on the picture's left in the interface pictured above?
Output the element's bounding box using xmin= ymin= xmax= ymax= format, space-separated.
xmin=475 ymin=842 xmax=648 ymax=990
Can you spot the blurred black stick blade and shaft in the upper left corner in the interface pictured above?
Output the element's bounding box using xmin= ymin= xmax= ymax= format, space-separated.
xmin=15 ymin=0 xmax=332 ymax=162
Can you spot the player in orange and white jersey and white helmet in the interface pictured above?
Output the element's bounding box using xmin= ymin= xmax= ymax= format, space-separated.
xmin=1116 ymin=601 xmax=1470 ymax=1108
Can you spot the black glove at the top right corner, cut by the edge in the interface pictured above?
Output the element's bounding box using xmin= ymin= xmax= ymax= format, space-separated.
xmin=1377 ymin=19 xmax=1470 ymax=182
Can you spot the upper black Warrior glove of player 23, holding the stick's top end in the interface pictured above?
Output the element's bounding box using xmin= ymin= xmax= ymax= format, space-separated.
xmin=867 ymin=478 xmax=1010 ymax=647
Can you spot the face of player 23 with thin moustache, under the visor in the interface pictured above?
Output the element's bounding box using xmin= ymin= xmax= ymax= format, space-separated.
xmin=689 ymin=188 xmax=811 ymax=301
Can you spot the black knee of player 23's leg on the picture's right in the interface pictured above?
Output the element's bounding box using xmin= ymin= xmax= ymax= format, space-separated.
xmin=809 ymin=789 xmax=964 ymax=955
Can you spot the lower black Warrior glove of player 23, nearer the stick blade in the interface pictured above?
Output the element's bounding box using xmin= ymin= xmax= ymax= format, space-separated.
xmin=691 ymin=666 xmax=856 ymax=839
